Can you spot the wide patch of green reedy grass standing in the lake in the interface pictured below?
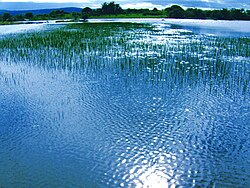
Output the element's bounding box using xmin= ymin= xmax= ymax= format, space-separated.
xmin=0 ymin=23 xmax=250 ymax=96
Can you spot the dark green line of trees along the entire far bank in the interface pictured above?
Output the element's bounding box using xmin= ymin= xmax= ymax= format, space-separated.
xmin=0 ymin=2 xmax=250 ymax=22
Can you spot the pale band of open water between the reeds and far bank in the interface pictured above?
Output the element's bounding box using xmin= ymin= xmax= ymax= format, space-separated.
xmin=0 ymin=18 xmax=250 ymax=37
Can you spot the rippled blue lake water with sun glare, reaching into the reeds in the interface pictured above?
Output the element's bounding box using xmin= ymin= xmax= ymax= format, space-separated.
xmin=0 ymin=20 xmax=250 ymax=188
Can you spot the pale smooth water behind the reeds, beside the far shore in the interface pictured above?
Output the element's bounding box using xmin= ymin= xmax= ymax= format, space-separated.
xmin=0 ymin=18 xmax=250 ymax=37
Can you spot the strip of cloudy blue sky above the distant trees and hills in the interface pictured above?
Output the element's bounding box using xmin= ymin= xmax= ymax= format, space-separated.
xmin=0 ymin=0 xmax=250 ymax=10
